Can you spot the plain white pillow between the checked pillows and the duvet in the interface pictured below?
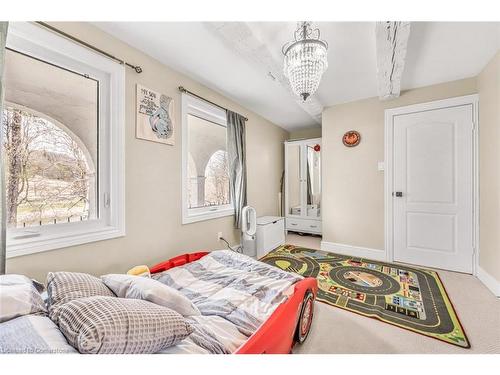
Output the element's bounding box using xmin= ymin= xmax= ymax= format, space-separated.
xmin=101 ymin=274 xmax=201 ymax=316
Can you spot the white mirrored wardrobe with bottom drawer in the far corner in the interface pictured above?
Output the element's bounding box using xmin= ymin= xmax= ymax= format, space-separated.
xmin=285 ymin=138 xmax=321 ymax=234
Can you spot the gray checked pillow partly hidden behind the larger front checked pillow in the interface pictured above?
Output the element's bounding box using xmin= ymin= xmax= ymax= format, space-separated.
xmin=47 ymin=272 xmax=115 ymax=318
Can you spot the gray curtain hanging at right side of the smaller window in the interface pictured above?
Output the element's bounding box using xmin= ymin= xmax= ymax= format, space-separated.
xmin=227 ymin=111 xmax=247 ymax=228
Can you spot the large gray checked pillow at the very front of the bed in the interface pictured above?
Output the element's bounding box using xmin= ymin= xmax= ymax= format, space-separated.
xmin=56 ymin=297 xmax=193 ymax=354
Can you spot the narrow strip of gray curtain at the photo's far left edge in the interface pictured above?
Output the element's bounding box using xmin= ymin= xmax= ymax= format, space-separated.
xmin=0 ymin=22 xmax=9 ymax=275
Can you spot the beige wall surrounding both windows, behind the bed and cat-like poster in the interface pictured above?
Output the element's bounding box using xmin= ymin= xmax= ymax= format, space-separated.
xmin=7 ymin=23 xmax=288 ymax=280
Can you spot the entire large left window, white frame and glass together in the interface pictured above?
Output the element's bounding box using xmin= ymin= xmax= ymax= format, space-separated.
xmin=4 ymin=23 xmax=124 ymax=257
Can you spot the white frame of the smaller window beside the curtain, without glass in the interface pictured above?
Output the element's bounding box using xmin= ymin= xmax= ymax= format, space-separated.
xmin=181 ymin=93 xmax=234 ymax=224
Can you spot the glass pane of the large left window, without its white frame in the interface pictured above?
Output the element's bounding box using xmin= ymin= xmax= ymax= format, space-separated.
xmin=0 ymin=50 xmax=99 ymax=229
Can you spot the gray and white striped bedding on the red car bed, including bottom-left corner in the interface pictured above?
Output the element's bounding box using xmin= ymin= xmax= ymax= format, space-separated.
xmin=0 ymin=250 xmax=301 ymax=354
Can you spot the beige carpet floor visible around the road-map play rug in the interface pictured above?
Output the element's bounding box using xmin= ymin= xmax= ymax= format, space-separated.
xmin=287 ymin=234 xmax=500 ymax=354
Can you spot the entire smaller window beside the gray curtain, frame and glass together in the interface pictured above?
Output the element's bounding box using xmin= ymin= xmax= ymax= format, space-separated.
xmin=182 ymin=94 xmax=234 ymax=224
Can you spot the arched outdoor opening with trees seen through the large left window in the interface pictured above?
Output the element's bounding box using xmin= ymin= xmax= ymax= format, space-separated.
xmin=2 ymin=106 xmax=95 ymax=228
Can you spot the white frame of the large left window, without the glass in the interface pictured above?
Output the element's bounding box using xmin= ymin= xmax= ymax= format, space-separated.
xmin=6 ymin=22 xmax=125 ymax=258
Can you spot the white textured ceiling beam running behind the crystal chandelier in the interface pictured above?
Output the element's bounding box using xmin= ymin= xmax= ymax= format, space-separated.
xmin=205 ymin=22 xmax=323 ymax=124
